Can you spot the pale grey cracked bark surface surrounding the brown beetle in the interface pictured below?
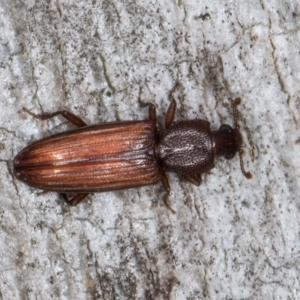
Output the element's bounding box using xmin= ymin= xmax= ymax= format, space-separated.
xmin=0 ymin=0 xmax=300 ymax=300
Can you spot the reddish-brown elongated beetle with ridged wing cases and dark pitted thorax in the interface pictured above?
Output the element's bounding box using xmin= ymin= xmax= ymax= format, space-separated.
xmin=13 ymin=83 xmax=251 ymax=212
